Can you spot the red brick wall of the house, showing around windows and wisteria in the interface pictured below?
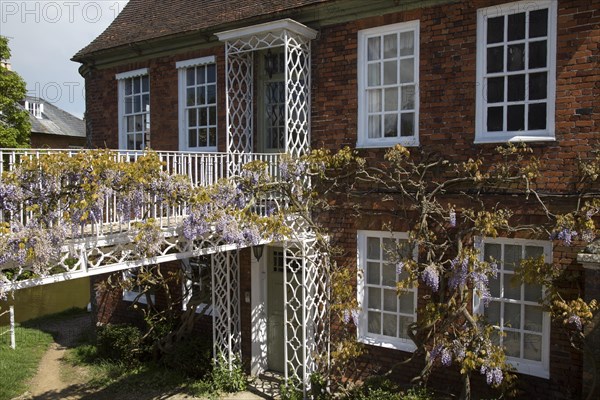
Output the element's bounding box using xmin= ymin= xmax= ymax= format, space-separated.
xmin=86 ymin=0 xmax=600 ymax=398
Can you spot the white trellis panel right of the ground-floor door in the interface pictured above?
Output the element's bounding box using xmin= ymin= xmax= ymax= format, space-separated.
xmin=284 ymin=238 xmax=329 ymax=398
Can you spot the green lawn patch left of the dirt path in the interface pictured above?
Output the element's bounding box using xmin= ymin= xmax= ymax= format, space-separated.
xmin=0 ymin=326 xmax=52 ymax=400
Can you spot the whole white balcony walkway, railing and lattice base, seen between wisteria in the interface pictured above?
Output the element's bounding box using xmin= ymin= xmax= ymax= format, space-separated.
xmin=0 ymin=149 xmax=281 ymax=293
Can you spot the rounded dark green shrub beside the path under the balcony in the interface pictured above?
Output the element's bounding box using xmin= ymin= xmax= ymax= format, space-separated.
xmin=97 ymin=324 xmax=148 ymax=365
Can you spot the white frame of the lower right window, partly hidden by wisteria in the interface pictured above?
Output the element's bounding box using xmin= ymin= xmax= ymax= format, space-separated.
xmin=473 ymin=237 xmax=553 ymax=379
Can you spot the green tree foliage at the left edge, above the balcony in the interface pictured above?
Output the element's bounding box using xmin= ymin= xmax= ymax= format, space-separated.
xmin=0 ymin=36 xmax=31 ymax=147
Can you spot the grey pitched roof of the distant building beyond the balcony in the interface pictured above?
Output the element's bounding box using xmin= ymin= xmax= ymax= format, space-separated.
xmin=25 ymin=97 xmax=85 ymax=137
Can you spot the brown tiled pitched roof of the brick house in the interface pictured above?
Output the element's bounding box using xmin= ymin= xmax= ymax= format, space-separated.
xmin=73 ymin=0 xmax=331 ymax=60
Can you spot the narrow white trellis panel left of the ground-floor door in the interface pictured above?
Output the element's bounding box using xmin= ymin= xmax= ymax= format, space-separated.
xmin=212 ymin=250 xmax=242 ymax=368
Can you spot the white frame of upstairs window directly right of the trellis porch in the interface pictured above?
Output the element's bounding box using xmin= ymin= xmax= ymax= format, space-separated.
xmin=356 ymin=20 xmax=420 ymax=148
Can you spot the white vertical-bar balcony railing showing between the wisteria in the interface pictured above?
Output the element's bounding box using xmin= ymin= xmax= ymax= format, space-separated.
xmin=0 ymin=149 xmax=280 ymax=239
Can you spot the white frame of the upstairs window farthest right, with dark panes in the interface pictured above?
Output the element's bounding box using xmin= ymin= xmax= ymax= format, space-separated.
xmin=475 ymin=0 xmax=558 ymax=143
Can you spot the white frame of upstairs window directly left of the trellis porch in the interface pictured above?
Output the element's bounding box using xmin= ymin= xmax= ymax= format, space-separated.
xmin=175 ymin=56 xmax=219 ymax=152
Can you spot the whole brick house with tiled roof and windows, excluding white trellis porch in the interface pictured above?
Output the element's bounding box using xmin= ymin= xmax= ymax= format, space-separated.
xmin=74 ymin=0 xmax=600 ymax=399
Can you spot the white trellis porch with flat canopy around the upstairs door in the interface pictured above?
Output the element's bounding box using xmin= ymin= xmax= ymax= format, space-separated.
xmin=217 ymin=20 xmax=317 ymax=171
